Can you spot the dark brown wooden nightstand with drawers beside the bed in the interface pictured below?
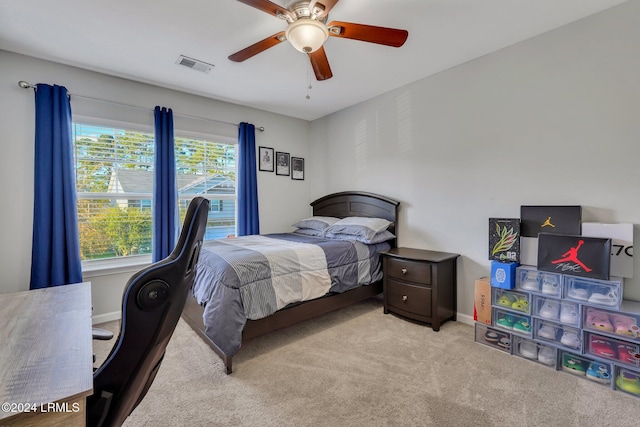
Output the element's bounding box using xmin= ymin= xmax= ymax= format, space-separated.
xmin=382 ymin=248 xmax=460 ymax=331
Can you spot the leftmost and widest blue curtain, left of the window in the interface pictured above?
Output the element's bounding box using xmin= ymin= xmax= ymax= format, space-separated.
xmin=30 ymin=83 xmax=82 ymax=289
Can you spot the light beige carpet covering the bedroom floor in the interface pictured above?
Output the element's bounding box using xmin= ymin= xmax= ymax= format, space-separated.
xmin=94 ymin=298 xmax=640 ymax=427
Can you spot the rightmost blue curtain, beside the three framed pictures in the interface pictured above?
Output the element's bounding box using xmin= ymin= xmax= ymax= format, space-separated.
xmin=238 ymin=122 xmax=260 ymax=236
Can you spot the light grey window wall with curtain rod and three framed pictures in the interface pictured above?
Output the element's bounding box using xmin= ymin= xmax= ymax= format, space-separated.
xmin=0 ymin=50 xmax=312 ymax=319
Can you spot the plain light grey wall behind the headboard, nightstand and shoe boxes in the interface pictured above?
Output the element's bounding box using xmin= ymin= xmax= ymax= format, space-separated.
xmin=312 ymin=2 xmax=640 ymax=324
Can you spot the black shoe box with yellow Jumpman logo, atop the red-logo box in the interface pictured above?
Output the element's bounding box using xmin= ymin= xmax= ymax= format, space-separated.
xmin=520 ymin=206 xmax=582 ymax=237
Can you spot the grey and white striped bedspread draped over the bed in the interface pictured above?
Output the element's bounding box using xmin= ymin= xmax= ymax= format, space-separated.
xmin=193 ymin=233 xmax=389 ymax=356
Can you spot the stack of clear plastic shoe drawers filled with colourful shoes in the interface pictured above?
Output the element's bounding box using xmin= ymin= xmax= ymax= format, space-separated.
xmin=475 ymin=206 xmax=640 ymax=397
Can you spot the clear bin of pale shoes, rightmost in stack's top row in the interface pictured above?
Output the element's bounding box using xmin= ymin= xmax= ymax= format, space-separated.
xmin=563 ymin=276 xmax=622 ymax=310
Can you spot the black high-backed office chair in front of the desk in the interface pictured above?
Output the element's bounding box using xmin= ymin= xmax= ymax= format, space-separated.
xmin=87 ymin=197 xmax=209 ymax=426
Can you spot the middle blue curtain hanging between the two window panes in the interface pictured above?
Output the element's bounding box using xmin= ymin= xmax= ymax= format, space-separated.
xmin=152 ymin=107 xmax=178 ymax=262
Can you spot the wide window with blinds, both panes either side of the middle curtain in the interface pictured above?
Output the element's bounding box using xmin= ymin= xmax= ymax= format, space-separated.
xmin=73 ymin=123 xmax=236 ymax=260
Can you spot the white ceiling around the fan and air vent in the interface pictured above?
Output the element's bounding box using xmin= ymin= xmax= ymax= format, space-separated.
xmin=0 ymin=0 xmax=626 ymax=120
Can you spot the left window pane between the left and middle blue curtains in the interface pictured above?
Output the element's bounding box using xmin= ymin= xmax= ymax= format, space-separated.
xmin=73 ymin=123 xmax=154 ymax=260
